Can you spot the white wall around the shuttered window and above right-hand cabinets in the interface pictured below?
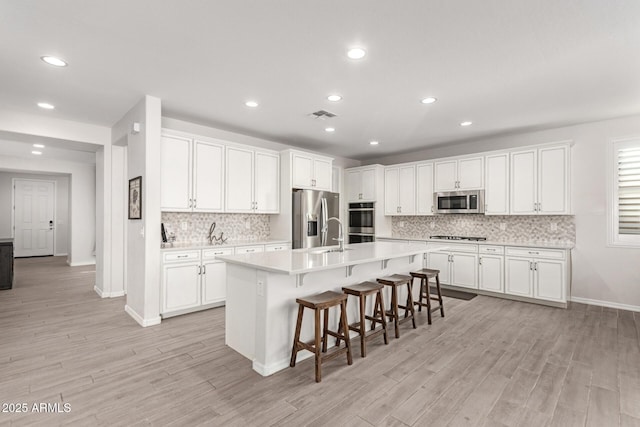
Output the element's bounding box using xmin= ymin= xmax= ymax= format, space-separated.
xmin=367 ymin=116 xmax=640 ymax=311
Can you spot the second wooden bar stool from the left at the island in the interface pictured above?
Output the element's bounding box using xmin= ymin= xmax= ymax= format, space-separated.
xmin=336 ymin=282 xmax=389 ymax=357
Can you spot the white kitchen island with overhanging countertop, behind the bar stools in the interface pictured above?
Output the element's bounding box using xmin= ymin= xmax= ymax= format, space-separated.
xmin=218 ymin=242 xmax=446 ymax=376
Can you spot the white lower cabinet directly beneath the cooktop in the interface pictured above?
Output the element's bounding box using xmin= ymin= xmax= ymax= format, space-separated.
xmin=427 ymin=243 xmax=478 ymax=289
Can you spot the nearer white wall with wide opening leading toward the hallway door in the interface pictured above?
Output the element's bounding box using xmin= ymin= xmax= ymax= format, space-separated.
xmin=0 ymin=155 xmax=96 ymax=265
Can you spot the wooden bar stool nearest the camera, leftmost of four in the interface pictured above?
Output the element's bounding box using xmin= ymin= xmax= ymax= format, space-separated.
xmin=289 ymin=291 xmax=353 ymax=383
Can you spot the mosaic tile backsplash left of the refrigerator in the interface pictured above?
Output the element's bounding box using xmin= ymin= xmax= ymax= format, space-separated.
xmin=162 ymin=212 xmax=270 ymax=243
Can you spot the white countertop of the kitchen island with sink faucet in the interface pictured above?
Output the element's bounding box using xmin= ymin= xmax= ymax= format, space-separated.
xmin=217 ymin=242 xmax=446 ymax=275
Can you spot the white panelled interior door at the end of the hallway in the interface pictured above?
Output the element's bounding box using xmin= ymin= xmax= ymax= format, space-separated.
xmin=13 ymin=179 xmax=55 ymax=257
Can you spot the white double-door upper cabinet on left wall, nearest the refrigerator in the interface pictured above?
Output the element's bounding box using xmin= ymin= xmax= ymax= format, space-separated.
xmin=225 ymin=146 xmax=280 ymax=213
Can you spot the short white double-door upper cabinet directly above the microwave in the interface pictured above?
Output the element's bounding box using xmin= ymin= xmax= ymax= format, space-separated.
xmin=434 ymin=157 xmax=484 ymax=191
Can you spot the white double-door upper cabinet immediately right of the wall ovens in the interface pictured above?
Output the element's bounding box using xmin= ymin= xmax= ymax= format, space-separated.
xmin=384 ymin=165 xmax=416 ymax=215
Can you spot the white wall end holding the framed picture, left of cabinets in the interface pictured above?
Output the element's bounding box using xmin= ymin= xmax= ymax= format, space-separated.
xmin=111 ymin=96 xmax=161 ymax=326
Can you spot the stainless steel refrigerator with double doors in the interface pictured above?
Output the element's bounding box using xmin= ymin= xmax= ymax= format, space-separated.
xmin=293 ymin=190 xmax=340 ymax=249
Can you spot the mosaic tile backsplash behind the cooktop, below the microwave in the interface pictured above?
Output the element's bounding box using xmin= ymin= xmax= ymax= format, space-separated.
xmin=392 ymin=214 xmax=576 ymax=243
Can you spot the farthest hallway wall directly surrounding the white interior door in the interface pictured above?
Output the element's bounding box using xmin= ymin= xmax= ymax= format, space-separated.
xmin=0 ymin=172 xmax=69 ymax=256
